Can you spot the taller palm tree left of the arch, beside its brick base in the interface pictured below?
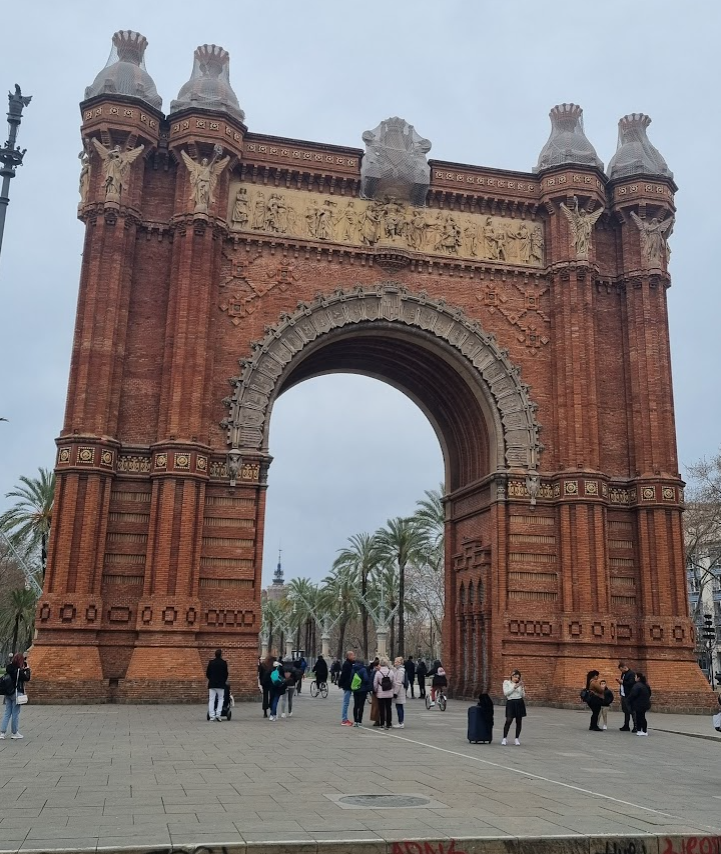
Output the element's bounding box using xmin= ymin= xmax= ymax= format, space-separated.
xmin=0 ymin=468 xmax=55 ymax=578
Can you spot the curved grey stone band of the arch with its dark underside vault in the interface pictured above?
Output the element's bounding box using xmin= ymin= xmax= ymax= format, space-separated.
xmin=223 ymin=282 xmax=541 ymax=488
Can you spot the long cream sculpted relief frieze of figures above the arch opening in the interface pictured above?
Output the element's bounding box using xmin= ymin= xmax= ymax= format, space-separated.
xmin=228 ymin=182 xmax=544 ymax=267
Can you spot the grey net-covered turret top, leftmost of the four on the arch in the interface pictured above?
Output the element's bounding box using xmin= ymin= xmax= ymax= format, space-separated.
xmin=85 ymin=30 xmax=163 ymax=110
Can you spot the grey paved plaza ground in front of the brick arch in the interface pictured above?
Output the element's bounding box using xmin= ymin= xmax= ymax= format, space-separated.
xmin=0 ymin=687 xmax=721 ymax=854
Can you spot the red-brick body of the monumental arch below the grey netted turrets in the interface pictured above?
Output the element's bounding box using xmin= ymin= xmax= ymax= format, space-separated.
xmin=31 ymin=88 xmax=708 ymax=708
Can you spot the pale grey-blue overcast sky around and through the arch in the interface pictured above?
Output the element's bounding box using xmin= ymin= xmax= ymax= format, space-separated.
xmin=0 ymin=0 xmax=721 ymax=583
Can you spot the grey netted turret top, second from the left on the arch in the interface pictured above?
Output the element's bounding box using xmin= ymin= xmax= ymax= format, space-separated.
xmin=170 ymin=44 xmax=245 ymax=121
